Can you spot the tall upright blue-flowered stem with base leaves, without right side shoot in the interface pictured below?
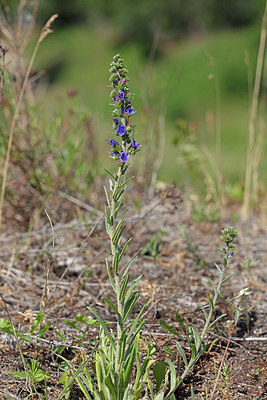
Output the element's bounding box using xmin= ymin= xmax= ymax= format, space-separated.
xmin=58 ymin=55 xmax=152 ymax=400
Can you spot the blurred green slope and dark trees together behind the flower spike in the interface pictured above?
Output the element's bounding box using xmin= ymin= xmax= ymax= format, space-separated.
xmin=1 ymin=0 xmax=267 ymax=222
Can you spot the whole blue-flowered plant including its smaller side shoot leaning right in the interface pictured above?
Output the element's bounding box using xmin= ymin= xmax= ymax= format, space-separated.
xmin=58 ymin=55 xmax=241 ymax=400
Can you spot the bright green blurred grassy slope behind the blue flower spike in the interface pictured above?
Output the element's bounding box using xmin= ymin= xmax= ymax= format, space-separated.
xmin=33 ymin=24 xmax=267 ymax=191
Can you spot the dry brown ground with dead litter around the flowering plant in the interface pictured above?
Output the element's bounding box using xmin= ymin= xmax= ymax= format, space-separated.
xmin=0 ymin=185 xmax=267 ymax=400
